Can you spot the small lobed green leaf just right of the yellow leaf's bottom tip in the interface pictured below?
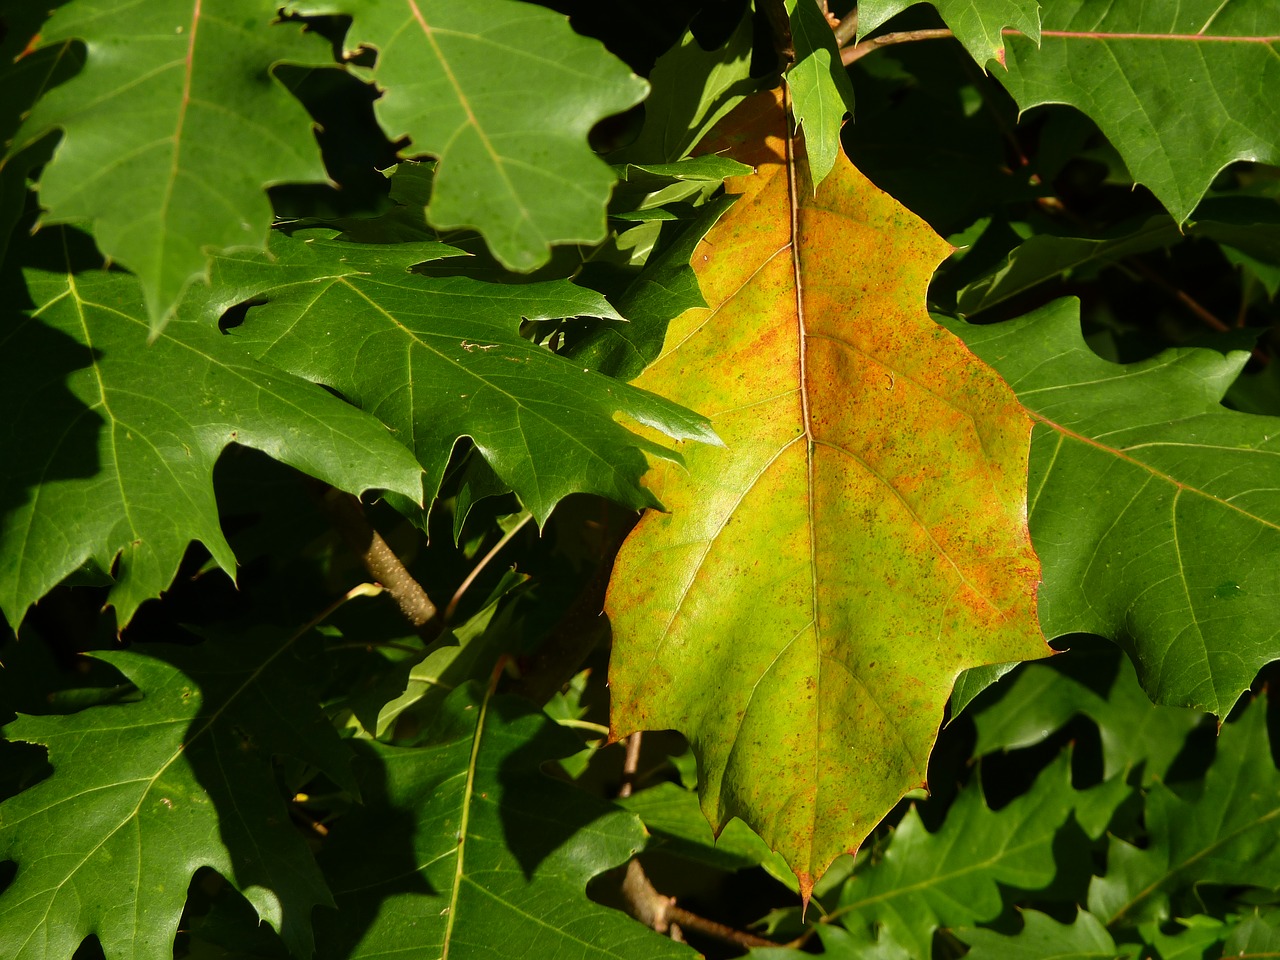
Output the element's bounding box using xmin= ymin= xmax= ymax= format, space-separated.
xmin=832 ymin=753 xmax=1087 ymax=957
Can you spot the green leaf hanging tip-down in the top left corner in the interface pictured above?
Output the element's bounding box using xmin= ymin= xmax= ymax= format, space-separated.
xmin=15 ymin=0 xmax=328 ymax=333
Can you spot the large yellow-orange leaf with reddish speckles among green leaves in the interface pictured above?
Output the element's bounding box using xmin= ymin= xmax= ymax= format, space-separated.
xmin=608 ymin=93 xmax=1048 ymax=893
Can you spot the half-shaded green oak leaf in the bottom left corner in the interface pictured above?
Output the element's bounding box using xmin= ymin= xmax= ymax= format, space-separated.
xmin=0 ymin=632 xmax=355 ymax=960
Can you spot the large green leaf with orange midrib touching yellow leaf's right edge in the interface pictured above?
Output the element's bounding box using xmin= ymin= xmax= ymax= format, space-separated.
xmin=951 ymin=300 xmax=1280 ymax=716
